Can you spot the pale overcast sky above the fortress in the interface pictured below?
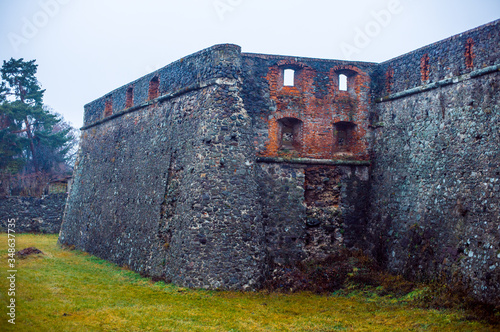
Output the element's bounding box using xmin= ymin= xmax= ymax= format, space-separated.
xmin=0 ymin=0 xmax=500 ymax=128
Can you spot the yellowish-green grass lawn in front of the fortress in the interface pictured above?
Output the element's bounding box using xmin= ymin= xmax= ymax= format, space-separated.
xmin=0 ymin=234 xmax=498 ymax=331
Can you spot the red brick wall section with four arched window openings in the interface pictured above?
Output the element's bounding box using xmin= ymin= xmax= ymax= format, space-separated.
xmin=259 ymin=60 xmax=370 ymax=160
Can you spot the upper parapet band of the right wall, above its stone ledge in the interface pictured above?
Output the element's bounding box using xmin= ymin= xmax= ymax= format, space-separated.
xmin=372 ymin=20 xmax=500 ymax=97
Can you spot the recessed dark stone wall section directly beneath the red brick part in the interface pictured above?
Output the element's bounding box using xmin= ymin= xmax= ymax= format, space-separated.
xmin=258 ymin=162 xmax=369 ymax=272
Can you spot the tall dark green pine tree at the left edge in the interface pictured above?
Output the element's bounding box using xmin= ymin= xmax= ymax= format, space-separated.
xmin=0 ymin=58 xmax=75 ymax=173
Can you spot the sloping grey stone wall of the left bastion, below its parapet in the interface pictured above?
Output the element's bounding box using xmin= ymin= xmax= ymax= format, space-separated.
xmin=59 ymin=45 xmax=264 ymax=289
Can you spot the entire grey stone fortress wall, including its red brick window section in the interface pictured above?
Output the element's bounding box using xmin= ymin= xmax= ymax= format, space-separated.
xmin=59 ymin=21 xmax=500 ymax=301
